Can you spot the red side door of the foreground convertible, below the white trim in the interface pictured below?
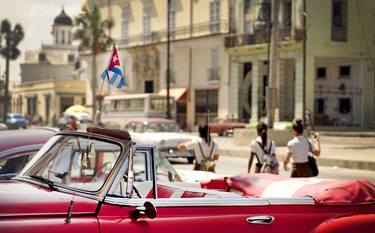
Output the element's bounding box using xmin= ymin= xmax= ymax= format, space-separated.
xmin=98 ymin=200 xmax=276 ymax=233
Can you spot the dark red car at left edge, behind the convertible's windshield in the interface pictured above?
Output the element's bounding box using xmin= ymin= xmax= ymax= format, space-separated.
xmin=0 ymin=128 xmax=57 ymax=180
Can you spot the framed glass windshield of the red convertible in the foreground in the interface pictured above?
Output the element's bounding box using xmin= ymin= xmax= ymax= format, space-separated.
xmin=20 ymin=135 xmax=121 ymax=191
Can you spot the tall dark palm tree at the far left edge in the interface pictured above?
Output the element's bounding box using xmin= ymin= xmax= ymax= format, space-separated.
xmin=0 ymin=19 xmax=24 ymax=122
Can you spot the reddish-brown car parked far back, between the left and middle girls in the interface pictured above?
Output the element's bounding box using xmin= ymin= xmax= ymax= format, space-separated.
xmin=209 ymin=118 xmax=245 ymax=136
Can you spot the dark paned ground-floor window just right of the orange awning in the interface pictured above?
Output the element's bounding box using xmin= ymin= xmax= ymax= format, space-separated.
xmin=195 ymin=90 xmax=218 ymax=125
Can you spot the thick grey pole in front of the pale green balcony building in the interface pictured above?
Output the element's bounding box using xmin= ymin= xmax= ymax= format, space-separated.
xmin=267 ymin=0 xmax=280 ymax=128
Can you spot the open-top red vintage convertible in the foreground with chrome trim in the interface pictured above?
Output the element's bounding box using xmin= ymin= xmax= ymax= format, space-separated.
xmin=0 ymin=128 xmax=375 ymax=233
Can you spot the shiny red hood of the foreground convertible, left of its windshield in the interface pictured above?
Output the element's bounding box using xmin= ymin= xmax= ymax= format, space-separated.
xmin=0 ymin=180 xmax=98 ymax=217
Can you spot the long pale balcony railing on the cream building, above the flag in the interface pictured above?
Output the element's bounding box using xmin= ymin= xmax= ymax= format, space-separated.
xmin=118 ymin=20 xmax=229 ymax=47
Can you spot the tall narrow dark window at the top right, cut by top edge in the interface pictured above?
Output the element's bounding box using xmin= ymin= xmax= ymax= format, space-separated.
xmin=331 ymin=0 xmax=348 ymax=41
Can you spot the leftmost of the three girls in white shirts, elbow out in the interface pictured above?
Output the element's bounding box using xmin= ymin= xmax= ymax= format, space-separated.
xmin=178 ymin=125 xmax=219 ymax=172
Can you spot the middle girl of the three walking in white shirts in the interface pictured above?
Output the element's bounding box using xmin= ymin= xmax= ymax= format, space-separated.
xmin=247 ymin=122 xmax=278 ymax=173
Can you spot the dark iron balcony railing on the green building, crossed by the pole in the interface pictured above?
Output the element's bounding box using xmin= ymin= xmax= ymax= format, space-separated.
xmin=224 ymin=28 xmax=304 ymax=48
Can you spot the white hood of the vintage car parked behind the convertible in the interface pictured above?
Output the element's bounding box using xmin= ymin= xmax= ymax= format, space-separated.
xmin=130 ymin=132 xmax=199 ymax=146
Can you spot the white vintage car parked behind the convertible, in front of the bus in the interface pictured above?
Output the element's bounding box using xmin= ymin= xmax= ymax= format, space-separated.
xmin=125 ymin=118 xmax=198 ymax=163
